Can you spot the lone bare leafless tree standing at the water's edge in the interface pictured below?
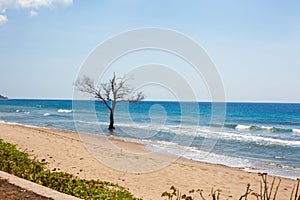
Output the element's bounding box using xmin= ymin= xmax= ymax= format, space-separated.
xmin=74 ymin=73 xmax=145 ymax=131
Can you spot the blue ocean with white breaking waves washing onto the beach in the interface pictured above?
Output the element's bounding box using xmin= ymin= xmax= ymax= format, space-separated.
xmin=0 ymin=99 xmax=300 ymax=179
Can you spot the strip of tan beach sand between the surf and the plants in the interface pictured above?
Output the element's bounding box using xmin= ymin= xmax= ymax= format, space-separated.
xmin=0 ymin=123 xmax=296 ymax=200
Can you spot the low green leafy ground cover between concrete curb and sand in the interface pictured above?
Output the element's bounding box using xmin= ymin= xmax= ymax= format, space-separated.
xmin=0 ymin=139 xmax=141 ymax=200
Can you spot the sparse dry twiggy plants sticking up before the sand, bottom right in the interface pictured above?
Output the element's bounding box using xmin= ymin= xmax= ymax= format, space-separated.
xmin=161 ymin=173 xmax=300 ymax=200
